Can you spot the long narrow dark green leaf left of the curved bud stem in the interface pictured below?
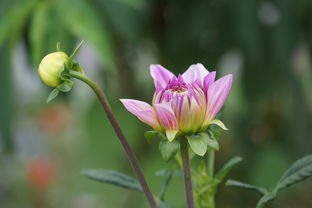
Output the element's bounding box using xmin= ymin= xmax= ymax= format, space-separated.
xmin=81 ymin=169 xmax=142 ymax=191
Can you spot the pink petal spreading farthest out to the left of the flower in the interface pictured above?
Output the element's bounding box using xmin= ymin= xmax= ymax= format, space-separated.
xmin=120 ymin=99 xmax=161 ymax=130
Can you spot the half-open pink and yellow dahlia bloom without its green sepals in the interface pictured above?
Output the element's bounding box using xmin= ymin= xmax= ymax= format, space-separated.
xmin=121 ymin=64 xmax=232 ymax=141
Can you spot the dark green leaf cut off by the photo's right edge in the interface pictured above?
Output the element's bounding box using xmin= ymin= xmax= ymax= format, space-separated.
xmin=273 ymin=155 xmax=312 ymax=193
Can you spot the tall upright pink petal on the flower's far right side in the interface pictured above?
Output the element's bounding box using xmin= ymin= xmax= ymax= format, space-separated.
xmin=206 ymin=74 xmax=233 ymax=121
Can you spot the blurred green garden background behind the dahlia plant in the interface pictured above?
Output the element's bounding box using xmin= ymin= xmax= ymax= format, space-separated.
xmin=0 ymin=0 xmax=312 ymax=208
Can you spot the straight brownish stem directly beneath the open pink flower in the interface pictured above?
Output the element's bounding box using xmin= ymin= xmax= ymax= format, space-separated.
xmin=180 ymin=138 xmax=195 ymax=208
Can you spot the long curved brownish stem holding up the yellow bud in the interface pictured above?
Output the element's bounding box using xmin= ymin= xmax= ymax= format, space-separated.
xmin=69 ymin=71 xmax=157 ymax=208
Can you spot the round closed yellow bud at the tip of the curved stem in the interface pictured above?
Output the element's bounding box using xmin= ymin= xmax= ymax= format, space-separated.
xmin=38 ymin=52 xmax=69 ymax=87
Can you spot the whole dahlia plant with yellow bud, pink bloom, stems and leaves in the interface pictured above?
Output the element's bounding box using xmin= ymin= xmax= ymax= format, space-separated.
xmin=38 ymin=42 xmax=312 ymax=208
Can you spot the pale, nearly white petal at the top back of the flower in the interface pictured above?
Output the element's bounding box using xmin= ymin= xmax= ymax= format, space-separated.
xmin=182 ymin=63 xmax=209 ymax=84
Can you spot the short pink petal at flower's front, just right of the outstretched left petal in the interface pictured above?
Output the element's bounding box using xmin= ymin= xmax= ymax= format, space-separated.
xmin=154 ymin=102 xmax=179 ymax=130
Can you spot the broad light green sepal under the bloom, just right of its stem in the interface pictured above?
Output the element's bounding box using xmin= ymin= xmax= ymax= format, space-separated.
xmin=186 ymin=133 xmax=209 ymax=156
